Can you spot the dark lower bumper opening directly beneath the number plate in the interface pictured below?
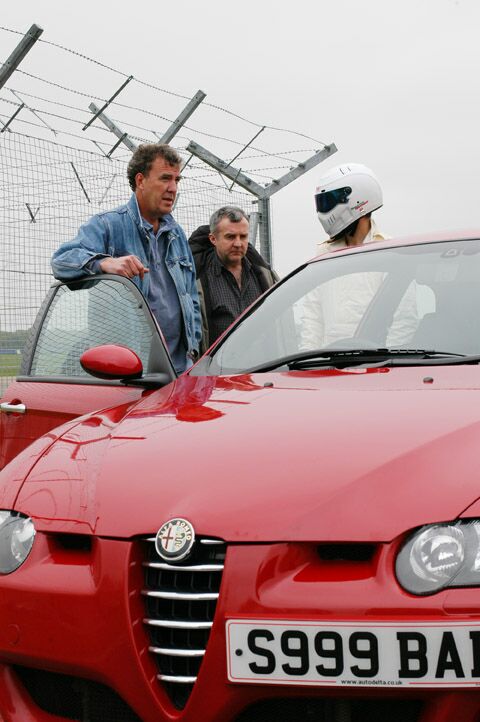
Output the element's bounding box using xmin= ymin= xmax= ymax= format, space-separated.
xmin=235 ymin=697 xmax=423 ymax=722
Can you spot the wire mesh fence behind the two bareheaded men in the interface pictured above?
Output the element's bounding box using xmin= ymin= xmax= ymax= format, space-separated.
xmin=0 ymin=133 xmax=254 ymax=386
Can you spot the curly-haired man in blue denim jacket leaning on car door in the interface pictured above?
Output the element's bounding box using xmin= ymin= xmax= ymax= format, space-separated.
xmin=52 ymin=143 xmax=202 ymax=373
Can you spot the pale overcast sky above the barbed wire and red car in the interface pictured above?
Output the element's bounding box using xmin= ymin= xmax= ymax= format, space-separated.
xmin=1 ymin=0 xmax=480 ymax=274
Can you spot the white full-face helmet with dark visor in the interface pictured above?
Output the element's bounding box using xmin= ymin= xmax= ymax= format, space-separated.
xmin=315 ymin=163 xmax=383 ymax=238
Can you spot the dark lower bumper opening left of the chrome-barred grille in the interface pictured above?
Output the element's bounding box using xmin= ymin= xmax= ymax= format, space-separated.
xmin=13 ymin=666 xmax=141 ymax=722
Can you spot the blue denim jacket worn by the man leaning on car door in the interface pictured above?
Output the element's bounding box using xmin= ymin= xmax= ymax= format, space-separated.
xmin=51 ymin=195 xmax=202 ymax=357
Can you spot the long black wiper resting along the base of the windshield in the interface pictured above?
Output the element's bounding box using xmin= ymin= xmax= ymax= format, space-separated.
xmin=249 ymin=348 xmax=480 ymax=373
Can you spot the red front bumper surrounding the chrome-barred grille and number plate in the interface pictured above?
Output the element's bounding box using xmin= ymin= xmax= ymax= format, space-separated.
xmin=0 ymin=533 xmax=480 ymax=722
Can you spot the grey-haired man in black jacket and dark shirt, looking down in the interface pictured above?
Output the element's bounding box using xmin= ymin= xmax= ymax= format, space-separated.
xmin=189 ymin=206 xmax=278 ymax=352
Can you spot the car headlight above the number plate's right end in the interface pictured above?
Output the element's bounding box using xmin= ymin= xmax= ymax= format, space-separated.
xmin=395 ymin=520 xmax=480 ymax=595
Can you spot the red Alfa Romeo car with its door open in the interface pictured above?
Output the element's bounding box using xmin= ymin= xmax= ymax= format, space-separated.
xmin=0 ymin=234 xmax=480 ymax=722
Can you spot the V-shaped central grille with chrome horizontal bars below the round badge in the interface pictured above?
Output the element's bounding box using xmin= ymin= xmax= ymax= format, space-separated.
xmin=142 ymin=537 xmax=226 ymax=709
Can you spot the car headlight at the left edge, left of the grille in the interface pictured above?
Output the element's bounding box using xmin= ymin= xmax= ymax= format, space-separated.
xmin=0 ymin=510 xmax=35 ymax=574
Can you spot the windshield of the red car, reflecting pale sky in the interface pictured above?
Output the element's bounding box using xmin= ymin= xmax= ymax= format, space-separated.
xmin=193 ymin=240 xmax=480 ymax=375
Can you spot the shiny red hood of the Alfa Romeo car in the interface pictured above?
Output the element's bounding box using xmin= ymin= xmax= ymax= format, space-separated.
xmin=11 ymin=366 xmax=480 ymax=542
